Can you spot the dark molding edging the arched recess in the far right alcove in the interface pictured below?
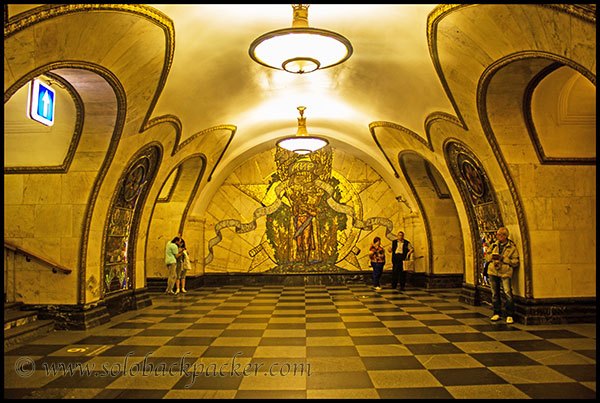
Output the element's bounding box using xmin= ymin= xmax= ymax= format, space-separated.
xmin=523 ymin=62 xmax=596 ymax=165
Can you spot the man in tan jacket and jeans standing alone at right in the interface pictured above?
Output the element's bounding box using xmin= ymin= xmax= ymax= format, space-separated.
xmin=485 ymin=227 xmax=519 ymax=323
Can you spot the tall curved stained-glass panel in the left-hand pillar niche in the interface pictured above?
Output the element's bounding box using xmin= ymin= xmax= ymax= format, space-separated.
xmin=100 ymin=141 xmax=163 ymax=298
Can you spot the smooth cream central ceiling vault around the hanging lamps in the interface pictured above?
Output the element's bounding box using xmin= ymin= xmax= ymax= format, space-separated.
xmin=145 ymin=4 xmax=452 ymax=182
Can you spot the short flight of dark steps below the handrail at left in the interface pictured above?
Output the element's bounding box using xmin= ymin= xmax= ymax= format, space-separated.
xmin=4 ymin=302 xmax=54 ymax=350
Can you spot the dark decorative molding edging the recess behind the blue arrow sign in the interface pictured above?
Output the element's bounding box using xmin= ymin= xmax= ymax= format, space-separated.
xmin=4 ymin=71 xmax=85 ymax=174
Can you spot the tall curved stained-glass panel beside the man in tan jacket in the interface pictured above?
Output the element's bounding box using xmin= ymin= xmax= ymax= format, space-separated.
xmin=444 ymin=141 xmax=503 ymax=286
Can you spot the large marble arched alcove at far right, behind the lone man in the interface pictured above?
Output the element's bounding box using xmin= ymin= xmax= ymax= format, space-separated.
xmin=479 ymin=52 xmax=596 ymax=298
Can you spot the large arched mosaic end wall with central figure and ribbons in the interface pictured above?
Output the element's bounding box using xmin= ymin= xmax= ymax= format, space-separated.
xmin=205 ymin=146 xmax=410 ymax=273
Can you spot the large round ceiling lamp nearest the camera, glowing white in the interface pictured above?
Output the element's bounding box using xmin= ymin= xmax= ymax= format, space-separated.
xmin=249 ymin=4 xmax=352 ymax=74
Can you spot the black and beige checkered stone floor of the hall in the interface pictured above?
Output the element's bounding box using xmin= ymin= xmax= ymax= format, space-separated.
xmin=4 ymin=284 xmax=596 ymax=399
